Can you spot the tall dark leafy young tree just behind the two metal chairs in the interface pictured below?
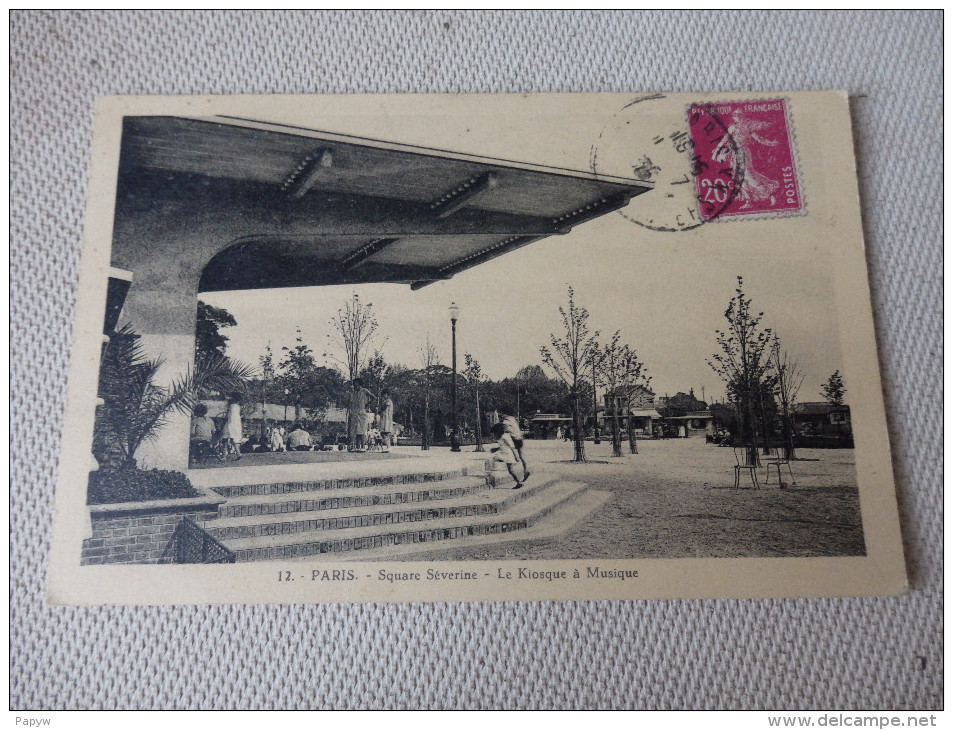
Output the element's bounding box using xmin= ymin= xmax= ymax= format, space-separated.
xmin=708 ymin=276 xmax=775 ymax=463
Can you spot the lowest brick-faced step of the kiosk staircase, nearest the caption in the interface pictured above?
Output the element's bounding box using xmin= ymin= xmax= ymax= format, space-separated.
xmin=222 ymin=482 xmax=586 ymax=562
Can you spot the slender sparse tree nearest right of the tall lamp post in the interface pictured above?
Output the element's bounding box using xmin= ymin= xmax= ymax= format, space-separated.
xmin=539 ymin=286 xmax=599 ymax=461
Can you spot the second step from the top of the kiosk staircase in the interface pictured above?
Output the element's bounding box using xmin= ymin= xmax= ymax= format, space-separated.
xmin=218 ymin=476 xmax=488 ymax=518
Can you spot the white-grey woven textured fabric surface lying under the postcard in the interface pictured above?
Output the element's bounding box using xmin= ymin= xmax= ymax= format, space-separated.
xmin=10 ymin=11 xmax=943 ymax=710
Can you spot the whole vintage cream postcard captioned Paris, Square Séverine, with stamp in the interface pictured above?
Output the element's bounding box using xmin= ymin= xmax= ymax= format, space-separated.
xmin=48 ymin=92 xmax=907 ymax=604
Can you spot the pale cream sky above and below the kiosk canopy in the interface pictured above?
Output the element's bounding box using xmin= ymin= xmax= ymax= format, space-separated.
xmin=193 ymin=95 xmax=848 ymax=402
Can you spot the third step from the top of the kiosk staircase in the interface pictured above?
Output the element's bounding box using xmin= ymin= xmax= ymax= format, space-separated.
xmin=203 ymin=475 xmax=556 ymax=540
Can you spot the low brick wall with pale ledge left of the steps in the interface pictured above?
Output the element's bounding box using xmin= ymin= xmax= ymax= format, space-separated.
xmin=80 ymin=495 xmax=225 ymax=565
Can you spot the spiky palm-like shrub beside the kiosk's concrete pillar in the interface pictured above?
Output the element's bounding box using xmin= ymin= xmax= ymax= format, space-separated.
xmin=93 ymin=325 xmax=253 ymax=469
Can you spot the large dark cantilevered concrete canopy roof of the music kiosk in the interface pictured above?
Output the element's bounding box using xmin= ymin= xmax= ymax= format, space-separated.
xmin=113 ymin=117 xmax=650 ymax=291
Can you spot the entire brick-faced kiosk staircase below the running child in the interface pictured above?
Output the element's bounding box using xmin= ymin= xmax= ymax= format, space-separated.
xmin=202 ymin=464 xmax=604 ymax=562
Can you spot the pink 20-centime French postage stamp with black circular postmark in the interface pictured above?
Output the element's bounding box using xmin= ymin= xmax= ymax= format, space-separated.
xmin=688 ymin=99 xmax=804 ymax=220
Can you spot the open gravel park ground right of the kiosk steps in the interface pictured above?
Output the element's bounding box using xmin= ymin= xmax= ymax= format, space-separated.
xmin=434 ymin=439 xmax=865 ymax=560
